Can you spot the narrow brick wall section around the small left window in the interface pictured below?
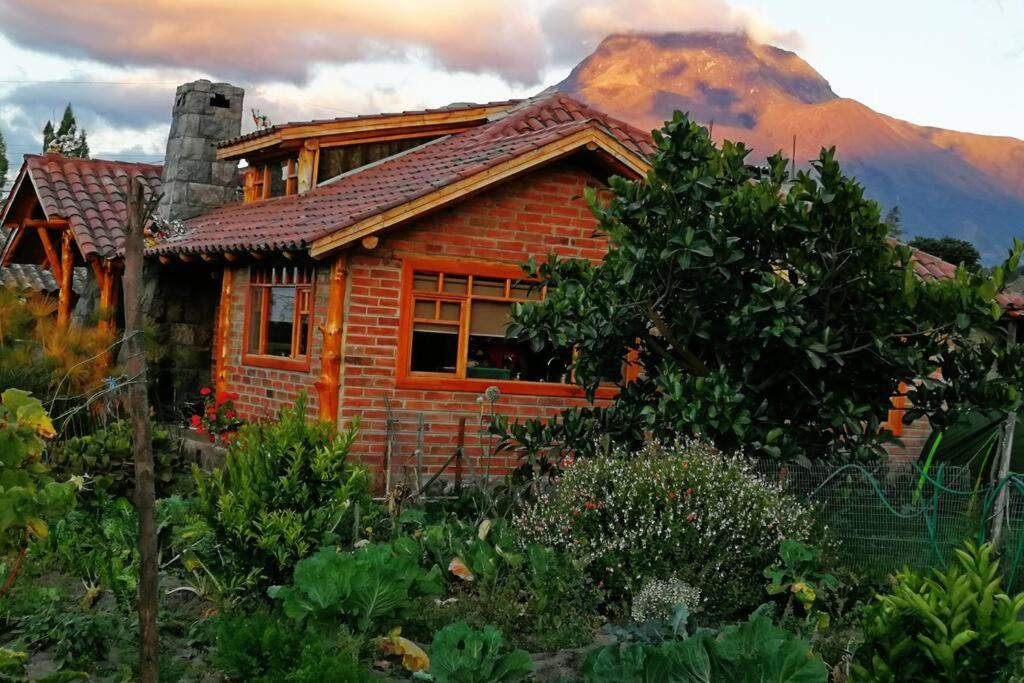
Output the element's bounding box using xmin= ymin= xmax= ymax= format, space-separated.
xmin=220 ymin=264 xmax=330 ymax=420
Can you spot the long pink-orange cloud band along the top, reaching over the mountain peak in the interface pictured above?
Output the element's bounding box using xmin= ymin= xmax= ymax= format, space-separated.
xmin=0 ymin=0 xmax=792 ymax=86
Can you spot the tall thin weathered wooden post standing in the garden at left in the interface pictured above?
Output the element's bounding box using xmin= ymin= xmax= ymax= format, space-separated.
xmin=122 ymin=181 xmax=159 ymax=683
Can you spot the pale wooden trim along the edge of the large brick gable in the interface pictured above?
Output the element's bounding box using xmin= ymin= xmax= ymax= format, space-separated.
xmin=309 ymin=128 xmax=650 ymax=258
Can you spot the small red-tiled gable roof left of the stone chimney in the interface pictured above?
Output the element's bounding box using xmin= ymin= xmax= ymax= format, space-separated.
xmin=0 ymin=154 xmax=161 ymax=259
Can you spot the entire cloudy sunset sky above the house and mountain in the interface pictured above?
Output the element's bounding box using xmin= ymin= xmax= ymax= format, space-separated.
xmin=0 ymin=0 xmax=1024 ymax=185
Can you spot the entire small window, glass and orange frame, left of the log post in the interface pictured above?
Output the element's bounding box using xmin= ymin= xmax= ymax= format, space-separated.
xmin=244 ymin=265 xmax=313 ymax=370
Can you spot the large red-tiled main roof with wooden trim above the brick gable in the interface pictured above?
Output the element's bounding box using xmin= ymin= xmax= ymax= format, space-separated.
xmin=148 ymin=93 xmax=653 ymax=254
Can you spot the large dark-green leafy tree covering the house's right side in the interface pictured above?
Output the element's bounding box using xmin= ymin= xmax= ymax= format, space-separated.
xmin=498 ymin=114 xmax=1024 ymax=460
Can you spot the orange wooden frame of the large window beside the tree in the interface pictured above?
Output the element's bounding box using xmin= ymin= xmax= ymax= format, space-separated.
xmin=396 ymin=258 xmax=614 ymax=398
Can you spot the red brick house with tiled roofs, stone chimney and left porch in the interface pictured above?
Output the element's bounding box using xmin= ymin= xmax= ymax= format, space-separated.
xmin=0 ymin=81 xmax=1024 ymax=469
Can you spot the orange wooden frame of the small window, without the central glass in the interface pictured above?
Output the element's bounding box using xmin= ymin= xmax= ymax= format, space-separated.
xmin=242 ymin=265 xmax=316 ymax=372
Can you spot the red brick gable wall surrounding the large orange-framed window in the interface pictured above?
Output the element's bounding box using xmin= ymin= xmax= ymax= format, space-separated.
xmin=340 ymin=162 xmax=605 ymax=477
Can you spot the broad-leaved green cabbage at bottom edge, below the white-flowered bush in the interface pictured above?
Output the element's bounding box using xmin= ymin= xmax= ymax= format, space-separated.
xmin=584 ymin=609 xmax=828 ymax=683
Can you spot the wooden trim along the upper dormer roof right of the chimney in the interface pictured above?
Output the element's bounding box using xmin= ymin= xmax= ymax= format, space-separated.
xmin=217 ymin=103 xmax=510 ymax=160
